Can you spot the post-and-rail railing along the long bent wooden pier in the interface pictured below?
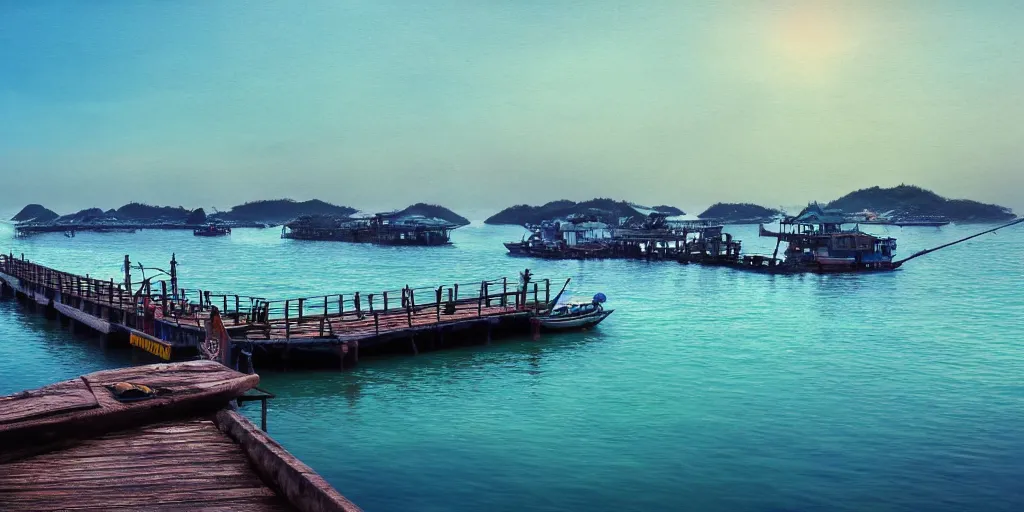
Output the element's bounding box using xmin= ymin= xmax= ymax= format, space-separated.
xmin=0 ymin=250 xmax=553 ymax=344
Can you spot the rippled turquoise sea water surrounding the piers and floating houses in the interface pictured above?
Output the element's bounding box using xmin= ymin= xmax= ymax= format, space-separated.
xmin=0 ymin=225 xmax=1024 ymax=511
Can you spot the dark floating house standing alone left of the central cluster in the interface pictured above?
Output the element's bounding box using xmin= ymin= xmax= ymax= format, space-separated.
xmin=281 ymin=213 xmax=459 ymax=246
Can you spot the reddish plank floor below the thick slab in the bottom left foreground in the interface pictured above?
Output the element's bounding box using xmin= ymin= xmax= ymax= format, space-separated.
xmin=0 ymin=418 xmax=295 ymax=512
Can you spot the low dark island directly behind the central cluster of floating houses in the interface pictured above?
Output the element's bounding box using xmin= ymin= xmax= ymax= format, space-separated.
xmin=483 ymin=199 xmax=685 ymax=225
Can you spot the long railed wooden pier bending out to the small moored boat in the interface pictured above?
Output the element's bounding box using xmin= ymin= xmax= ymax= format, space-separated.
xmin=0 ymin=254 xmax=551 ymax=368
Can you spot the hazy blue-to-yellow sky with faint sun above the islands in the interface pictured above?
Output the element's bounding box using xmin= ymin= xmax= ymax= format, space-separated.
xmin=0 ymin=0 xmax=1024 ymax=216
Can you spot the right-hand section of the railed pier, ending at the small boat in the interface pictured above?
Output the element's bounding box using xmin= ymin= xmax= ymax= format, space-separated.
xmin=232 ymin=270 xmax=552 ymax=366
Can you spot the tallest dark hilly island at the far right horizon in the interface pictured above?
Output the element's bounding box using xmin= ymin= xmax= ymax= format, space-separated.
xmin=826 ymin=184 xmax=1017 ymax=222
